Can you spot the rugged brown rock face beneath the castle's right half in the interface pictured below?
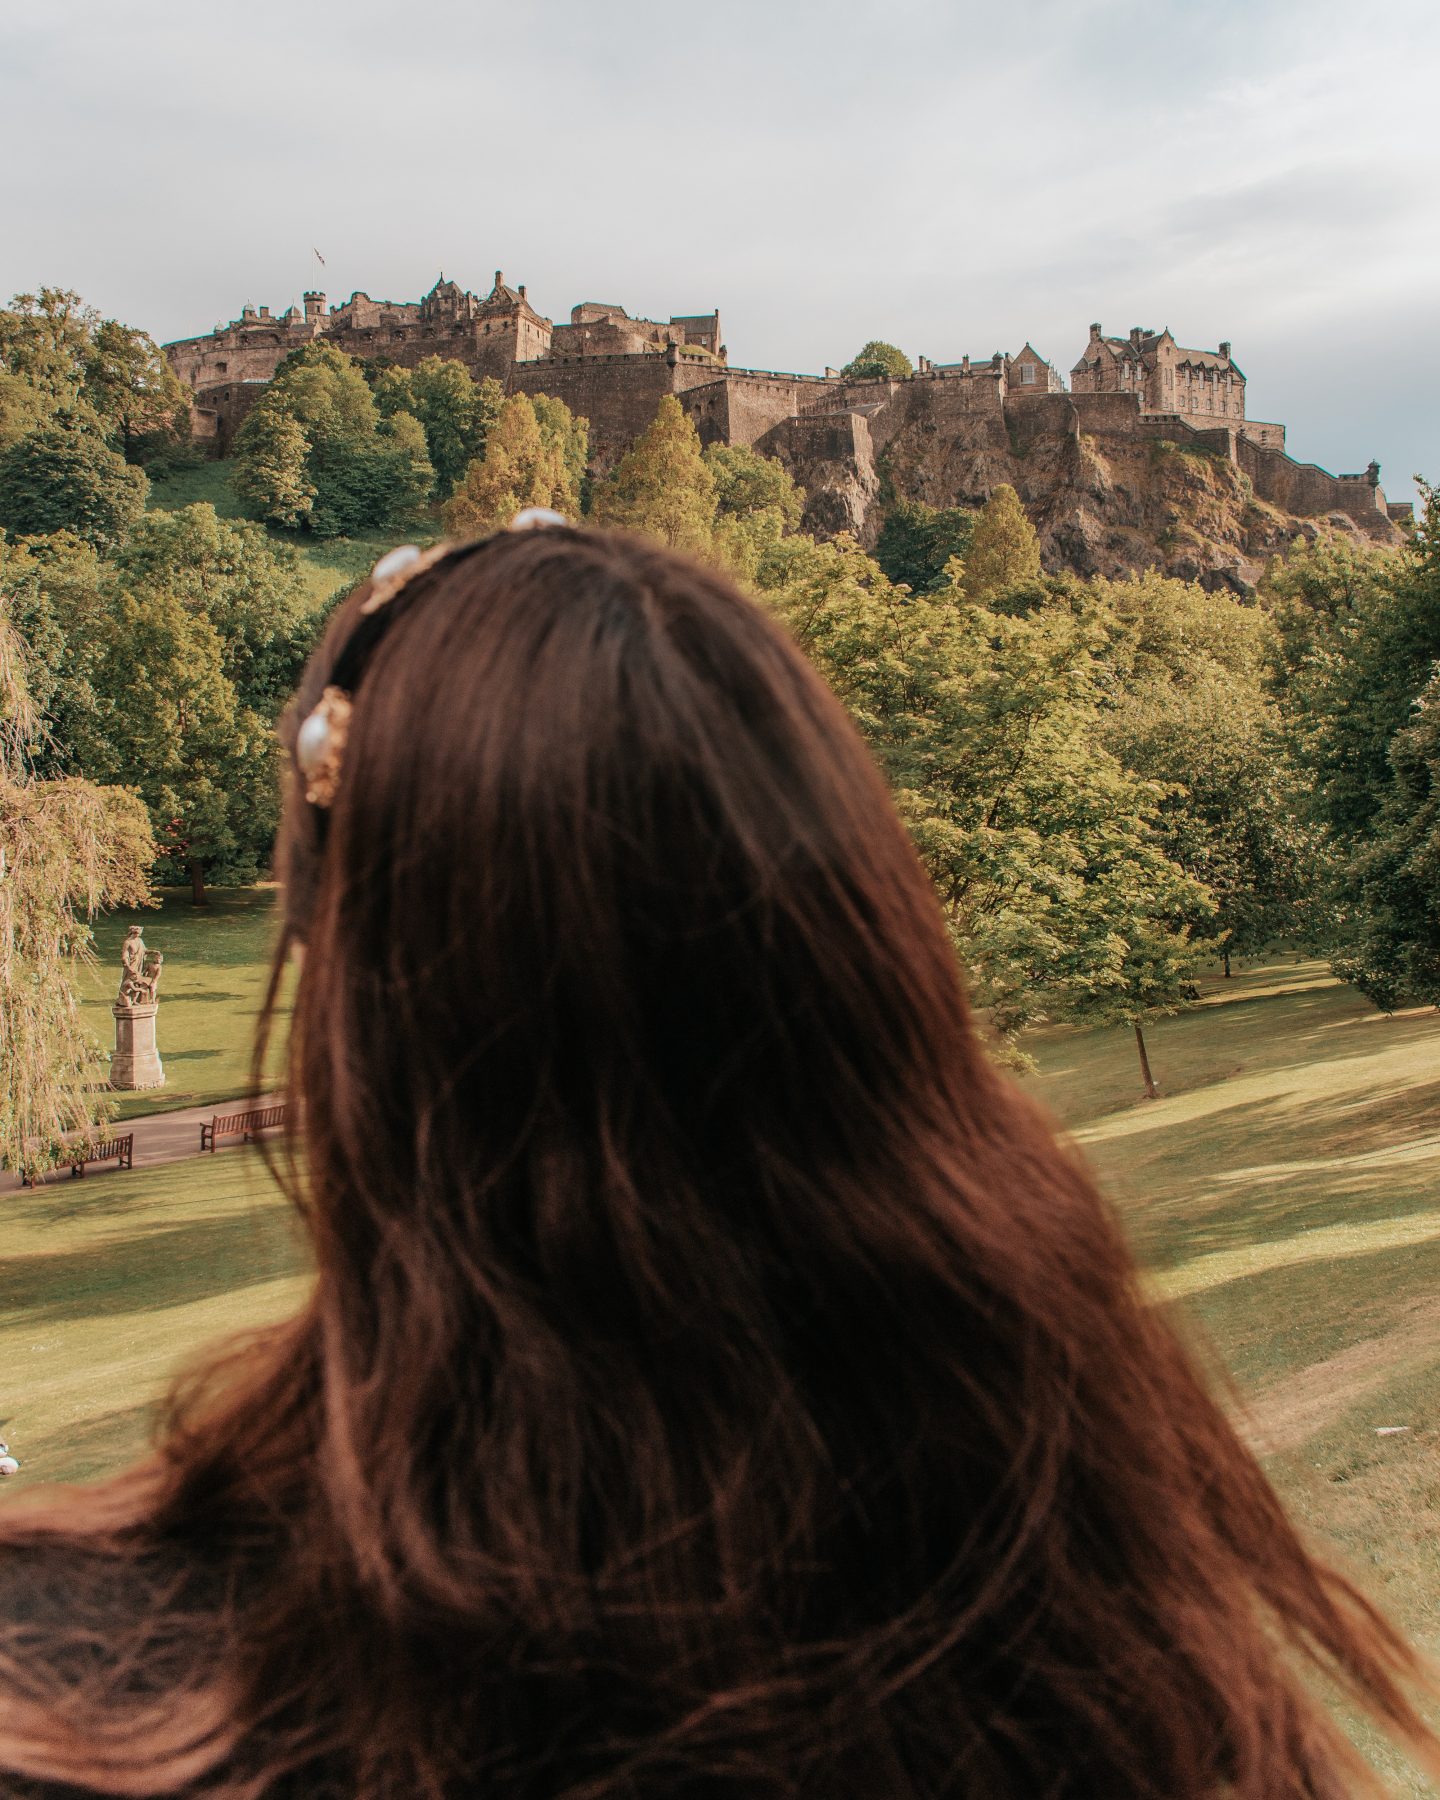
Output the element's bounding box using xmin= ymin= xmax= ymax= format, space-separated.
xmin=760 ymin=394 xmax=1402 ymax=590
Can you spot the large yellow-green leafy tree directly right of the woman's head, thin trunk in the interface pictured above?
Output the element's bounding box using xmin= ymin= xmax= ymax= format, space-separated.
xmin=765 ymin=538 xmax=1213 ymax=1091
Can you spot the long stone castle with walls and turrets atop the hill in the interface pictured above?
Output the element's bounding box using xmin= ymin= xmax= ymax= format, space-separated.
xmin=166 ymin=270 xmax=1409 ymax=538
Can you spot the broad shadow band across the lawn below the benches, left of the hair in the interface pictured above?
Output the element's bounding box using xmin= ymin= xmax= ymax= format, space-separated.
xmin=0 ymin=1210 xmax=306 ymax=1325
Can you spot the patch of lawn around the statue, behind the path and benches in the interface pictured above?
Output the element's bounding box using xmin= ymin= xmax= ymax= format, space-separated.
xmin=81 ymin=887 xmax=281 ymax=1118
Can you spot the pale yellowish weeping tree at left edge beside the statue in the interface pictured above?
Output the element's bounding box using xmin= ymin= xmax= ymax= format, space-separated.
xmin=0 ymin=603 xmax=155 ymax=1170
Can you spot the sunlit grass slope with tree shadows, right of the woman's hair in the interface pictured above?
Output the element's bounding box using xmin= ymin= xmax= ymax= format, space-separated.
xmin=1030 ymin=958 xmax=1440 ymax=1795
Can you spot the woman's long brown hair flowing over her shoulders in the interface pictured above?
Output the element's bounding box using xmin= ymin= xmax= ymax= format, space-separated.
xmin=0 ymin=529 xmax=1427 ymax=1800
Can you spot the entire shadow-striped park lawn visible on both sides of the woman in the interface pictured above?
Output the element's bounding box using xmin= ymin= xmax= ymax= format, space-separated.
xmin=0 ymin=957 xmax=1440 ymax=1795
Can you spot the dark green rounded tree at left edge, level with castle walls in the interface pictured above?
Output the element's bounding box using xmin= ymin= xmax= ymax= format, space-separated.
xmin=0 ymin=426 xmax=149 ymax=549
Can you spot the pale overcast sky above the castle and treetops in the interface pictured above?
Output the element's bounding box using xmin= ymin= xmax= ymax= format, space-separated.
xmin=0 ymin=0 xmax=1440 ymax=497
